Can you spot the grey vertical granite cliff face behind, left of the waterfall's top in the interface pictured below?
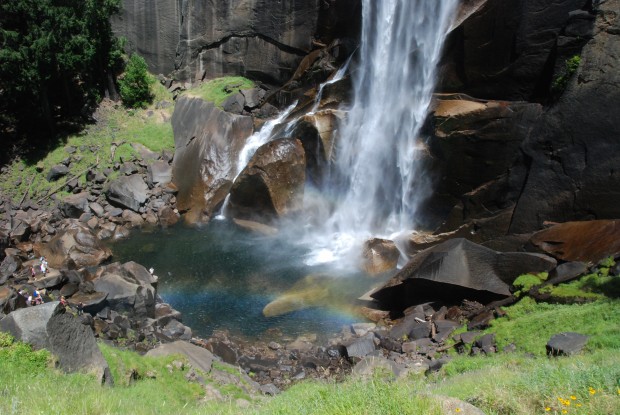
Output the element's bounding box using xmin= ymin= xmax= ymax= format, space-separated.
xmin=112 ymin=0 xmax=359 ymax=84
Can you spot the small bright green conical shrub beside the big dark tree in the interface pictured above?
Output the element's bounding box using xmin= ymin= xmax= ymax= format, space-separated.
xmin=118 ymin=53 xmax=154 ymax=108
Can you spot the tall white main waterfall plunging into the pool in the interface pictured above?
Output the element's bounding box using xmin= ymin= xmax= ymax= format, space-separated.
xmin=309 ymin=0 xmax=457 ymax=263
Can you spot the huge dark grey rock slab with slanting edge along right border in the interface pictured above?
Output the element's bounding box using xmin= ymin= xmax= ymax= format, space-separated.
xmin=510 ymin=0 xmax=620 ymax=233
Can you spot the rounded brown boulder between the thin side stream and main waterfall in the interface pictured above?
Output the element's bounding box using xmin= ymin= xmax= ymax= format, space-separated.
xmin=228 ymin=138 xmax=306 ymax=221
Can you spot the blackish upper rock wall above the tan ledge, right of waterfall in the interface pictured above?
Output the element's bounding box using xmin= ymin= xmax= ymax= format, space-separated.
xmin=440 ymin=0 xmax=591 ymax=101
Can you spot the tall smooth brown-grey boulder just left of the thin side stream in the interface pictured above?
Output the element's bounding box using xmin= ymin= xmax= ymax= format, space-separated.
xmin=172 ymin=97 xmax=253 ymax=222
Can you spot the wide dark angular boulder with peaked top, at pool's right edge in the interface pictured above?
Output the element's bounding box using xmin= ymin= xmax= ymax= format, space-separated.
xmin=371 ymin=238 xmax=556 ymax=310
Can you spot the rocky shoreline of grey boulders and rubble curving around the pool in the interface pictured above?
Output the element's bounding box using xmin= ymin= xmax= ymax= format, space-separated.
xmin=0 ymin=135 xmax=617 ymax=394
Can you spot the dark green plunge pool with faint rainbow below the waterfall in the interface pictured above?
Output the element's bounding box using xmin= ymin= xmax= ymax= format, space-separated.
xmin=112 ymin=221 xmax=387 ymax=338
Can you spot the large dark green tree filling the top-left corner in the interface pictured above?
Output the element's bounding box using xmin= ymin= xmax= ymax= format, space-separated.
xmin=0 ymin=0 xmax=120 ymax=143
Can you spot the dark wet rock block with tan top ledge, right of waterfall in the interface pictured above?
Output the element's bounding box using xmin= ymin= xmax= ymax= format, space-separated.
xmin=423 ymin=94 xmax=542 ymax=234
